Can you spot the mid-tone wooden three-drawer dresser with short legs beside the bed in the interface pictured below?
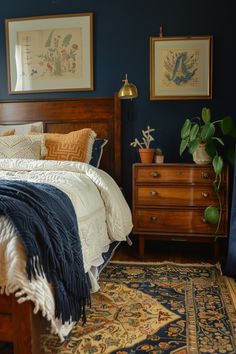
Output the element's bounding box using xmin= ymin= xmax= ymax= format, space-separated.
xmin=132 ymin=163 xmax=229 ymax=258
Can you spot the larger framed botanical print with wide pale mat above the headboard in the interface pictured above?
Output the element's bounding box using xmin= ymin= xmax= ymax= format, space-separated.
xmin=5 ymin=13 xmax=94 ymax=94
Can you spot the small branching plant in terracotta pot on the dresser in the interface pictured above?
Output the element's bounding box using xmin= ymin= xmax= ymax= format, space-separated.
xmin=130 ymin=125 xmax=155 ymax=163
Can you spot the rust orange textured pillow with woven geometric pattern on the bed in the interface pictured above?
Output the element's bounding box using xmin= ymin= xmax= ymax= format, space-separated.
xmin=44 ymin=128 xmax=96 ymax=163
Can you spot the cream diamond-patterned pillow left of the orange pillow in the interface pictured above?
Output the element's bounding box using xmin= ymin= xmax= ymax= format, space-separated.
xmin=0 ymin=135 xmax=47 ymax=160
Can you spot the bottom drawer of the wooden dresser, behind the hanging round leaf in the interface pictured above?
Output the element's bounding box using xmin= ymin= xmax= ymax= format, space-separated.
xmin=134 ymin=209 xmax=225 ymax=236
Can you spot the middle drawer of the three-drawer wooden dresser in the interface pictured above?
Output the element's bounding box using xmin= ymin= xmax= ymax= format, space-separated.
xmin=135 ymin=184 xmax=225 ymax=206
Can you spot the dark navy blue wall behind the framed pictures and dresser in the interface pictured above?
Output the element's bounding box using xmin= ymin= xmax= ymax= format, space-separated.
xmin=0 ymin=0 xmax=236 ymax=199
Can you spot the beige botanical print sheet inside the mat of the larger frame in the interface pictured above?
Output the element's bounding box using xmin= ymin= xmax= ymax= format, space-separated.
xmin=17 ymin=27 xmax=84 ymax=84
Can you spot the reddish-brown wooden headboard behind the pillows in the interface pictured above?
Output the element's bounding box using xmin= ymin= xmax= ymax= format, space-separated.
xmin=0 ymin=95 xmax=121 ymax=184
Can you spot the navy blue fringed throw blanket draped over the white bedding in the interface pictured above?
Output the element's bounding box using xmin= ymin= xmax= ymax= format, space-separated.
xmin=0 ymin=180 xmax=90 ymax=323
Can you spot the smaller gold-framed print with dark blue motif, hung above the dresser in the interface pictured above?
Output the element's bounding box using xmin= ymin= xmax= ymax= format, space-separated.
xmin=150 ymin=36 xmax=213 ymax=100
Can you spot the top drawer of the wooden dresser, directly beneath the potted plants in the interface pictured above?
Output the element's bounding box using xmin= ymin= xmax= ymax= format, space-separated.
xmin=134 ymin=164 xmax=226 ymax=184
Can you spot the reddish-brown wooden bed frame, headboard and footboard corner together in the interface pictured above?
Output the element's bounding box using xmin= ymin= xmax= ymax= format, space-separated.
xmin=0 ymin=95 xmax=121 ymax=354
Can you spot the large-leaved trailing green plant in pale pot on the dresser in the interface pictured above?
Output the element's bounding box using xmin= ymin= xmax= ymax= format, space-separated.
xmin=179 ymin=107 xmax=236 ymax=233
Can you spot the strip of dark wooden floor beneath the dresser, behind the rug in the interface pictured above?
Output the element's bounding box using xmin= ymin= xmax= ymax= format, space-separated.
xmin=112 ymin=236 xmax=226 ymax=264
